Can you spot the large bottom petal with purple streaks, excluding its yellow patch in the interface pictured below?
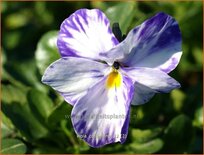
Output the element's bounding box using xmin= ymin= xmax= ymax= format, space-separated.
xmin=71 ymin=77 xmax=134 ymax=147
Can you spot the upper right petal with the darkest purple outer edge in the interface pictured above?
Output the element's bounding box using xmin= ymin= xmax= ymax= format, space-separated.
xmin=116 ymin=13 xmax=182 ymax=73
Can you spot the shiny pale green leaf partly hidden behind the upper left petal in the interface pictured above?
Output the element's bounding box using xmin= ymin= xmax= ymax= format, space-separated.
xmin=35 ymin=31 xmax=60 ymax=75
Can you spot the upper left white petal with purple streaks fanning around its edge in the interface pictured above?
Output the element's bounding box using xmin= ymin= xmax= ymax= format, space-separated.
xmin=57 ymin=9 xmax=118 ymax=60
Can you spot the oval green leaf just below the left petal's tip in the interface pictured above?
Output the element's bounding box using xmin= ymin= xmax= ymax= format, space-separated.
xmin=27 ymin=89 xmax=54 ymax=123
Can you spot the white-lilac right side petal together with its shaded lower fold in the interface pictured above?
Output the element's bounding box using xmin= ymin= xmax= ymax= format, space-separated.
xmin=123 ymin=67 xmax=180 ymax=105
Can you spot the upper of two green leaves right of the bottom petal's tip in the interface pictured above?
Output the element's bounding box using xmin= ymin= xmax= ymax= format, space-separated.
xmin=132 ymin=127 xmax=162 ymax=143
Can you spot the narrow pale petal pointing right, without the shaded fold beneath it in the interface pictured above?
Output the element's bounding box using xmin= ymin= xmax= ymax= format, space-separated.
xmin=123 ymin=67 xmax=180 ymax=94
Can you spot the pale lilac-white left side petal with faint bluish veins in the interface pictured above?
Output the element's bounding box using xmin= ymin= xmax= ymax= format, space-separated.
xmin=42 ymin=57 xmax=108 ymax=105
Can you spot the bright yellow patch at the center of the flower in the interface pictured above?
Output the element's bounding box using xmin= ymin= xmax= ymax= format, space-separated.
xmin=106 ymin=69 xmax=122 ymax=89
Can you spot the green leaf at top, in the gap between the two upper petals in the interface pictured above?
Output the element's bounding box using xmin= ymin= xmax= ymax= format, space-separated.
xmin=105 ymin=2 xmax=136 ymax=33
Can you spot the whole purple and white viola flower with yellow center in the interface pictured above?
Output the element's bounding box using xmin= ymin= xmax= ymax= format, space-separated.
xmin=42 ymin=9 xmax=182 ymax=147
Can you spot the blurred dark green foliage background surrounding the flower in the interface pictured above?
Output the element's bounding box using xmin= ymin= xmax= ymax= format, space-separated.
xmin=1 ymin=1 xmax=203 ymax=154
